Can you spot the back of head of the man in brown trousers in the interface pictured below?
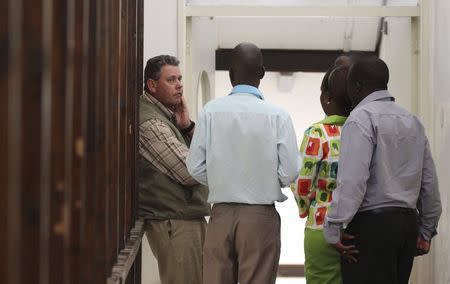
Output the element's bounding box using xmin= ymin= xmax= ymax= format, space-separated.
xmin=229 ymin=43 xmax=264 ymax=87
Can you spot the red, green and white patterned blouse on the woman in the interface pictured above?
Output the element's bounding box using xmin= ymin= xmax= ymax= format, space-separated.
xmin=291 ymin=115 xmax=346 ymax=230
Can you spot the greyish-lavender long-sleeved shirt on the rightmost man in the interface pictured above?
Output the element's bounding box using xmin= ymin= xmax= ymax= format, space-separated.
xmin=324 ymin=91 xmax=442 ymax=244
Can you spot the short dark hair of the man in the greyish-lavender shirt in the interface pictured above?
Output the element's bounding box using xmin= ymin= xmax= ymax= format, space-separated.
xmin=348 ymin=56 xmax=389 ymax=89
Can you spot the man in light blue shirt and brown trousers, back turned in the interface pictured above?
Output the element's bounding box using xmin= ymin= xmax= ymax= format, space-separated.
xmin=187 ymin=43 xmax=298 ymax=284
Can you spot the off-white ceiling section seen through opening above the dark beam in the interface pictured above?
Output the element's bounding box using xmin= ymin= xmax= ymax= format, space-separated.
xmin=216 ymin=17 xmax=379 ymax=51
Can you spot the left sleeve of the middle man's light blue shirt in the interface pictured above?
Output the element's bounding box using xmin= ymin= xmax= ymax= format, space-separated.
xmin=186 ymin=112 xmax=208 ymax=185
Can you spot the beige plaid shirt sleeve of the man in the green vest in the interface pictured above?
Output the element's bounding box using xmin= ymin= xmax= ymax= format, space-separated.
xmin=139 ymin=119 xmax=198 ymax=186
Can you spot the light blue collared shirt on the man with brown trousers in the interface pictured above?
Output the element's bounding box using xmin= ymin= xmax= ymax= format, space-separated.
xmin=186 ymin=85 xmax=299 ymax=204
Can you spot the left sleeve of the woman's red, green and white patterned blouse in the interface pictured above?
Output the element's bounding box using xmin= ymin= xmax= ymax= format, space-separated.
xmin=291 ymin=126 xmax=323 ymax=218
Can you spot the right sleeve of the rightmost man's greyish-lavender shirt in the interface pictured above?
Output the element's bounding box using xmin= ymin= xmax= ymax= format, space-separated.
xmin=417 ymin=139 xmax=442 ymax=240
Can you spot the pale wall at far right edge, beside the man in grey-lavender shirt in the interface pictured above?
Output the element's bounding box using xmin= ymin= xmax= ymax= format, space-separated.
xmin=416 ymin=0 xmax=450 ymax=284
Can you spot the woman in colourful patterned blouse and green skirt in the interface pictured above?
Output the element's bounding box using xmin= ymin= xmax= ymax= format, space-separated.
xmin=291 ymin=57 xmax=351 ymax=284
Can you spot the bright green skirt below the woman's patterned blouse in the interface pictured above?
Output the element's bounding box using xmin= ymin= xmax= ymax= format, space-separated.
xmin=304 ymin=228 xmax=342 ymax=284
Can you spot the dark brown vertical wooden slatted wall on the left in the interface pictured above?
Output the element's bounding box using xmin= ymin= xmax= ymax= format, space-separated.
xmin=0 ymin=0 xmax=143 ymax=283
